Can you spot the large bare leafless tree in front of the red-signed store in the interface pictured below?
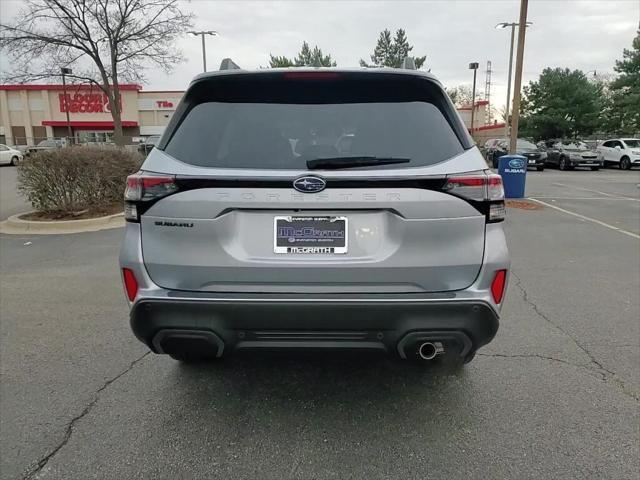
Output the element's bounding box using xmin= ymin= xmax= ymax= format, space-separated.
xmin=0 ymin=0 xmax=193 ymax=145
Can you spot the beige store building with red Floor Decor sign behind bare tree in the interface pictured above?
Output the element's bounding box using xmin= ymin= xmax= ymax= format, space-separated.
xmin=0 ymin=84 xmax=184 ymax=145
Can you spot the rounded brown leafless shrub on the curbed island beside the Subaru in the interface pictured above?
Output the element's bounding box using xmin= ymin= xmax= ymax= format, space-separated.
xmin=18 ymin=146 xmax=142 ymax=213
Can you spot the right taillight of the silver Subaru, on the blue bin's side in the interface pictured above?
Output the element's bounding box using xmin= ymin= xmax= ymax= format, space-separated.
xmin=442 ymin=172 xmax=505 ymax=223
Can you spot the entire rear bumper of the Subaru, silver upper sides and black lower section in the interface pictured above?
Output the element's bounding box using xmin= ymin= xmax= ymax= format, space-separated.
xmin=120 ymin=219 xmax=510 ymax=357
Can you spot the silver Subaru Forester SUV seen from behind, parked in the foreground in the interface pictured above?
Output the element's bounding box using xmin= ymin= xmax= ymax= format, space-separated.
xmin=120 ymin=69 xmax=509 ymax=365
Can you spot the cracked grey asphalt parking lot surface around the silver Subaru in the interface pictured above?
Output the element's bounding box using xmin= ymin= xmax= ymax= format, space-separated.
xmin=0 ymin=165 xmax=640 ymax=479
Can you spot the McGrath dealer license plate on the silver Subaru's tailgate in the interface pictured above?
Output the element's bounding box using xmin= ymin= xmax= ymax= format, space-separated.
xmin=273 ymin=216 xmax=347 ymax=254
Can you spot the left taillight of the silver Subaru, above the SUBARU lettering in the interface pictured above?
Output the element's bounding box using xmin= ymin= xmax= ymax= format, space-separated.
xmin=124 ymin=172 xmax=178 ymax=222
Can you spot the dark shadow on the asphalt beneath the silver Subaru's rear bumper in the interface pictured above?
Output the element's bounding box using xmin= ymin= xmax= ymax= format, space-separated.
xmin=160 ymin=354 xmax=475 ymax=430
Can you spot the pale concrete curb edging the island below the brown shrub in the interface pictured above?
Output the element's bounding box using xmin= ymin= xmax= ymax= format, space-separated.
xmin=0 ymin=212 xmax=125 ymax=235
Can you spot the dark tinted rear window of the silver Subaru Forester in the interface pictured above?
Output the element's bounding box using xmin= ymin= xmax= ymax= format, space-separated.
xmin=164 ymin=72 xmax=464 ymax=169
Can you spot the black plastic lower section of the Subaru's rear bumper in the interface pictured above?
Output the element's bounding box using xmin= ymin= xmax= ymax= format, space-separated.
xmin=130 ymin=295 xmax=498 ymax=358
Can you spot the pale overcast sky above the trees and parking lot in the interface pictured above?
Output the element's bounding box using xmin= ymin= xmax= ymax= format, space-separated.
xmin=0 ymin=0 xmax=640 ymax=109
